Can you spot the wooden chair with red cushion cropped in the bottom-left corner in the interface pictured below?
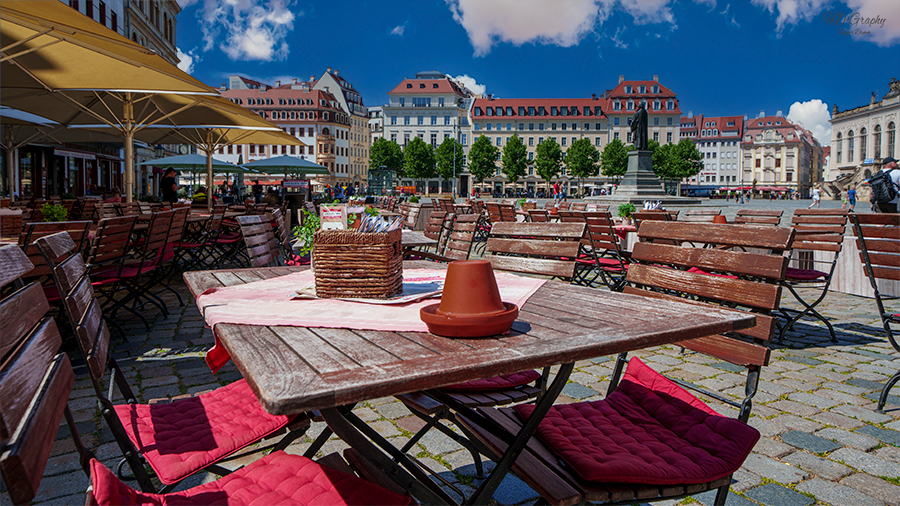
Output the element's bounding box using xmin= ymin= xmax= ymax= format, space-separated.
xmin=0 ymin=243 xmax=414 ymax=506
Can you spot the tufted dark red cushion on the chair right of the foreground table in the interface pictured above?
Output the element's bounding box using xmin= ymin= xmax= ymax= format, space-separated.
xmin=513 ymin=358 xmax=759 ymax=485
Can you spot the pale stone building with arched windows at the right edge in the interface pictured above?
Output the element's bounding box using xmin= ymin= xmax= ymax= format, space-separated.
xmin=825 ymin=78 xmax=900 ymax=184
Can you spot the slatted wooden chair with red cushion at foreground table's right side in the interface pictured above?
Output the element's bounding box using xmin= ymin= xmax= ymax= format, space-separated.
xmin=457 ymin=221 xmax=794 ymax=506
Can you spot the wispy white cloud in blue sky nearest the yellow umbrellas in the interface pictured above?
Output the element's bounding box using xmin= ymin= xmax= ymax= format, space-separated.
xmin=199 ymin=0 xmax=303 ymax=61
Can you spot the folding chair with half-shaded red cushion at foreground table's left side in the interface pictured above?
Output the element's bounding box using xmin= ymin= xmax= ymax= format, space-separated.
xmin=38 ymin=234 xmax=309 ymax=492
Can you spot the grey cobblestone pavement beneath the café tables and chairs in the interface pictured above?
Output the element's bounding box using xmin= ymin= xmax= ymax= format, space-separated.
xmin=0 ymin=204 xmax=900 ymax=506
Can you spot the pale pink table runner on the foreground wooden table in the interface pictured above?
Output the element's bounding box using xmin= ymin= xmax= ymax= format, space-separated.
xmin=197 ymin=269 xmax=545 ymax=372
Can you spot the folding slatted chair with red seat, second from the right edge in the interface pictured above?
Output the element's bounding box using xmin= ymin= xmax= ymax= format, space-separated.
xmin=778 ymin=209 xmax=847 ymax=342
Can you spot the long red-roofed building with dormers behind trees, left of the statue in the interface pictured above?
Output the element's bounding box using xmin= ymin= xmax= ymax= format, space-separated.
xmin=469 ymin=95 xmax=609 ymax=195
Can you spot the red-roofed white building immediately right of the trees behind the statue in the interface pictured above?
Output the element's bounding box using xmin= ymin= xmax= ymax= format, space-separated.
xmin=678 ymin=112 xmax=744 ymax=186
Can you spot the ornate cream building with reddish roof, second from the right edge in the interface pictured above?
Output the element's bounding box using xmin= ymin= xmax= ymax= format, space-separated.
xmin=741 ymin=111 xmax=824 ymax=197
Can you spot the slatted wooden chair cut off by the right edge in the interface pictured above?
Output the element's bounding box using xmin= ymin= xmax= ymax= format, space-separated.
xmin=849 ymin=213 xmax=900 ymax=412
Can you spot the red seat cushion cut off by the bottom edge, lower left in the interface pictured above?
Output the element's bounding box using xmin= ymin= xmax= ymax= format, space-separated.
xmin=91 ymin=451 xmax=412 ymax=506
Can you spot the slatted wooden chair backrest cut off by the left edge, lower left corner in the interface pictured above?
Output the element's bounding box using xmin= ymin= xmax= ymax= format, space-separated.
xmin=0 ymin=243 xmax=78 ymax=504
